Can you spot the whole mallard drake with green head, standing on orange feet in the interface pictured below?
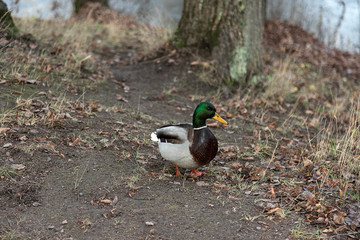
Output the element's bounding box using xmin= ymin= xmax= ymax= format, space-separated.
xmin=151 ymin=102 xmax=227 ymax=176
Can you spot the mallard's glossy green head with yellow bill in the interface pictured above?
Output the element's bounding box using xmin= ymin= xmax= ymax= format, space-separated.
xmin=193 ymin=102 xmax=227 ymax=128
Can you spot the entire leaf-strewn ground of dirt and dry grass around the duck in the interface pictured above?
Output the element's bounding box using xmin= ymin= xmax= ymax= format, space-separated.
xmin=0 ymin=3 xmax=360 ymax=240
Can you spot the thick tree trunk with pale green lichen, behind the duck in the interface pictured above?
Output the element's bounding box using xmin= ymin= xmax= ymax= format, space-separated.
xmin=176 ymin=0 xmax=264 ymax=84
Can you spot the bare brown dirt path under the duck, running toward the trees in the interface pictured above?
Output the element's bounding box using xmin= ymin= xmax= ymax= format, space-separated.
xmin=0 ymin=56 xmax=315 ymax=240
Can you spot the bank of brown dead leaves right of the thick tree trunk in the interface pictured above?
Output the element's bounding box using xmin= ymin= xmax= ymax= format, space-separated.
xmin=264 ymin=20 xmax=360 ymax=80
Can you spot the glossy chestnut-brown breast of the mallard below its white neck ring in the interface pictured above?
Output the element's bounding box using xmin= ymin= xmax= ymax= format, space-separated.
xmin=190 ymin=127 xmax=218 ymax=166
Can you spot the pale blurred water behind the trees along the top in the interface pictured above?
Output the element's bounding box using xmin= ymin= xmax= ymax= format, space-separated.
xmin=4 ymin=0 xmax=360 ymax=52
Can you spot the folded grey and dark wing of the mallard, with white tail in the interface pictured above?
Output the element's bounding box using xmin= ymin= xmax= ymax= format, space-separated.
xmin=151 ymin=124 xmax=193 ymax=144
